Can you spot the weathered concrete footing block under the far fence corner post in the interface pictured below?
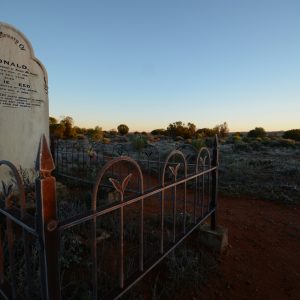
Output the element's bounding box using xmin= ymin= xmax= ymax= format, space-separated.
xmin=199 ymin=224 xmax=228 ymax=253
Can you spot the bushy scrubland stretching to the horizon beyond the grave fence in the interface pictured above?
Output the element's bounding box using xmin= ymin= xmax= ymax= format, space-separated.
xmin=50 ymin=117 xmax=300 ymax=203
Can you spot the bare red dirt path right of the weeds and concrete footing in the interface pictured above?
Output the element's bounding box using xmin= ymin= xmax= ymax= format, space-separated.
xmin=199 ymin=198 xmax=300 ymax=300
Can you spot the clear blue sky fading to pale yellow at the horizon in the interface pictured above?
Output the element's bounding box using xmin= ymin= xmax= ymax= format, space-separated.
xmin=0 ymin=0 xmax=300 ymax=131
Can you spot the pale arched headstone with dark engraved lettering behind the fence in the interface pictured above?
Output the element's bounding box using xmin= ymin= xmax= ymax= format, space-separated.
xmin=0 ymin=23 xmax=49 ymax=175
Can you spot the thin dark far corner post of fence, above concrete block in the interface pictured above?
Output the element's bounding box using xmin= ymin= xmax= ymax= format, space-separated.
xmin=210 ymin=135 xmax=219 ymax=230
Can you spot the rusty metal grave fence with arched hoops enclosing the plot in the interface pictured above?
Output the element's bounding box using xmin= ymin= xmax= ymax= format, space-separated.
xmin=0 ymin=137 xmax=218 ymax=300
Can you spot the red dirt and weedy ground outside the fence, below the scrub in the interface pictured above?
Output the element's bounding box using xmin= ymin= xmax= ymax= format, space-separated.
xmin=128 ymin=197 xmax=300 ymax=300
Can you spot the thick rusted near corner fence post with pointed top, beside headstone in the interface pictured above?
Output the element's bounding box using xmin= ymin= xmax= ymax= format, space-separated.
xmin=35 ymin=136 xmax=61 ymax=300
